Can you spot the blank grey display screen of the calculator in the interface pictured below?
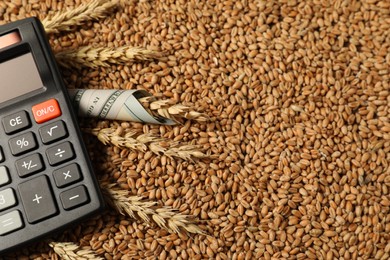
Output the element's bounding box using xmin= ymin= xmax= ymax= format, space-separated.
xmin=0 ymin=53 xmax=43 ymax=103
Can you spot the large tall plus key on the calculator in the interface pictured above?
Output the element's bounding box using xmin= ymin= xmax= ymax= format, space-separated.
xmin=19 ymin=175 xmax=57 ymax=223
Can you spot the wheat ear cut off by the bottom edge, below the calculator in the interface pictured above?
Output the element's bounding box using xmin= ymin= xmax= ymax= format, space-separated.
xmin=49 ymin=242 xmax=104 ymax=260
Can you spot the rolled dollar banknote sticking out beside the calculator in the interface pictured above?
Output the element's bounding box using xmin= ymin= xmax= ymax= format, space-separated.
xmin=68 ymin=89 xmax=176 ymax=125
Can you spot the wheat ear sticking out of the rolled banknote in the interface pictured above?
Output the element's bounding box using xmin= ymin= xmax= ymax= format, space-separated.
xmin=138 ymin=96 xmax=210 ymax=123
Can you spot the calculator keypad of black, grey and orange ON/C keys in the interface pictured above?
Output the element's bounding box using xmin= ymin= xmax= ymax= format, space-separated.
xmin=0 ymin=99 xmax=90 ymax=236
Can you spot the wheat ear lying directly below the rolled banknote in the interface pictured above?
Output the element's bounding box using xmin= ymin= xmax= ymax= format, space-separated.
xmin=83 ymin=127 xmax=208 ymax=161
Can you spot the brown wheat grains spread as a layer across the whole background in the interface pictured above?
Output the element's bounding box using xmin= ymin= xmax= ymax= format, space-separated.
xmin=0 ymin=0 xmax=390 ymax=259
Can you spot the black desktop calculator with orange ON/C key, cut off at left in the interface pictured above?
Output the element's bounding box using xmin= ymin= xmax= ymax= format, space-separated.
xmin=0 ymin=18 xmax=104 ymax=254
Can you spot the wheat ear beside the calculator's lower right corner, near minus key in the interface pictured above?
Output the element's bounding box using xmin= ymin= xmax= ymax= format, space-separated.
xmin=102 ymin=184 xmax=205 ymax=234
